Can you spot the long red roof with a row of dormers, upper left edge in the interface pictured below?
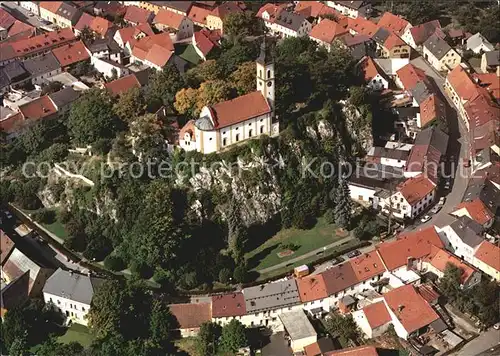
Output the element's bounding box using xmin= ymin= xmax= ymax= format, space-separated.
xmin=0 ymin=27 xmax=76 ymax=60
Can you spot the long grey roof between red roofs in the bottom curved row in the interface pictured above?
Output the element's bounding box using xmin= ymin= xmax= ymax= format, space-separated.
xmin=243 ymin=279 xmax=300 ymax=313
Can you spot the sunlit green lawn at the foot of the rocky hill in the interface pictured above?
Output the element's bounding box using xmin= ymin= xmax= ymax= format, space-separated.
xmin=245 ymin=218 xmax=350 ymax=270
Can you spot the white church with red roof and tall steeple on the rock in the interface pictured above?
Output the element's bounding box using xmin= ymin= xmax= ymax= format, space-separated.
xmin=179 ymin=43 xmax=279 ymax=154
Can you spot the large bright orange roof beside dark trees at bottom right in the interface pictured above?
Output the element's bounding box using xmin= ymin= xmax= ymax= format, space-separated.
xmin=384 ymin=284 xmax=439 ymax=334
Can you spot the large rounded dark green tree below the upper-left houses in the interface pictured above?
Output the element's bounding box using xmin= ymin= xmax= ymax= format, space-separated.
xmin=68 ymin=89 xmax=121 ymax=145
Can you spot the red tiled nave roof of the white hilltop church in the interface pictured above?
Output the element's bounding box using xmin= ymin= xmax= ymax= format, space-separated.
xmin=211 ymin=91 xmax=271 ymax=129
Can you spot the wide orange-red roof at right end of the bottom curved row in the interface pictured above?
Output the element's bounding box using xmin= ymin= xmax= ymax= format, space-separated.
xmin=377 ymin=226 xmax=444 ymax=271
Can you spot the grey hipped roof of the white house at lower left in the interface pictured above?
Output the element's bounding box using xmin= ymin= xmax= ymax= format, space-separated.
xmin=43 ymin=268 xmax=102 ymax=305
